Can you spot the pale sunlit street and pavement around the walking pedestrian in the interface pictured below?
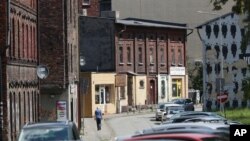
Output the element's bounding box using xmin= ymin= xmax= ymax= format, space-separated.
xmin=81 ymin=105 xmax=201 ymax=141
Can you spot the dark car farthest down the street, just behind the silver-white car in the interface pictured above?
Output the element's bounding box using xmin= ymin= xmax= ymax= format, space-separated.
xmin=171 ymin=98 xmax=194 ymax=111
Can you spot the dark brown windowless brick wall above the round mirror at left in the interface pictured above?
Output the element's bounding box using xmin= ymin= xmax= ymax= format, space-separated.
xmin=39 ymin=0 xmax=66 ymax=86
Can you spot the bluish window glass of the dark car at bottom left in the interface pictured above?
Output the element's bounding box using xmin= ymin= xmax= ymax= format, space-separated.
xmin=19 ymin=127 xmax=68 ymax=141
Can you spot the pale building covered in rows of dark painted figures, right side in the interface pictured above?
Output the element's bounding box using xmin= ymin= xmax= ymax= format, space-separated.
xmin=197 ymin=13 xmax=250 ymax=109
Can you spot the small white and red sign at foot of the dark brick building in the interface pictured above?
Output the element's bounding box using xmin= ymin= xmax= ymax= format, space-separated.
xmin=56 ymin=101 xmax=67 ymax=121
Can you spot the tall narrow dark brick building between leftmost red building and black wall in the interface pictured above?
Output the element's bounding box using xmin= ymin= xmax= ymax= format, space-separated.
xmin=38 ymin=0 xmax=80 ymax=126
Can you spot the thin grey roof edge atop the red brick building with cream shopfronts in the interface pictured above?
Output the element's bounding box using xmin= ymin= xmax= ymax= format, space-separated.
xmin=115 ymin=18 xmax=192 ymax=29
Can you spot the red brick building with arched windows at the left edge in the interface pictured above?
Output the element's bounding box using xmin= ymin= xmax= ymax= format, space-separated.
xmin=0 ymin=0 xmax=40 ymax=141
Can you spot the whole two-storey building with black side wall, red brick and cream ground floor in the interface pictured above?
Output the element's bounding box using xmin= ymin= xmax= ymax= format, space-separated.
xmin=79 ymin=16 xmax=189 ymax=116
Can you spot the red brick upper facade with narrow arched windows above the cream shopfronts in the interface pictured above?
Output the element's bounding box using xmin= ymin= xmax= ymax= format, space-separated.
xmin=116 ymin=27 xmax=185 ymax=74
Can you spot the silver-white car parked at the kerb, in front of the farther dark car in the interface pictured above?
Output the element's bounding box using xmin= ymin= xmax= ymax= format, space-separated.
xmin=155 ymin=102 xmax=184 ymax=120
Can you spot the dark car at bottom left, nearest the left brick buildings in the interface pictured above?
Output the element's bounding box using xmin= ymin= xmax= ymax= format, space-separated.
xmin=18 ymin=121 xmax=81 ymax=141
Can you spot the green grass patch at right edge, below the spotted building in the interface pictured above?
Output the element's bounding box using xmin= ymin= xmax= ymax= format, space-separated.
xmin=218 ymin=108 xmax=250 ymax=125
